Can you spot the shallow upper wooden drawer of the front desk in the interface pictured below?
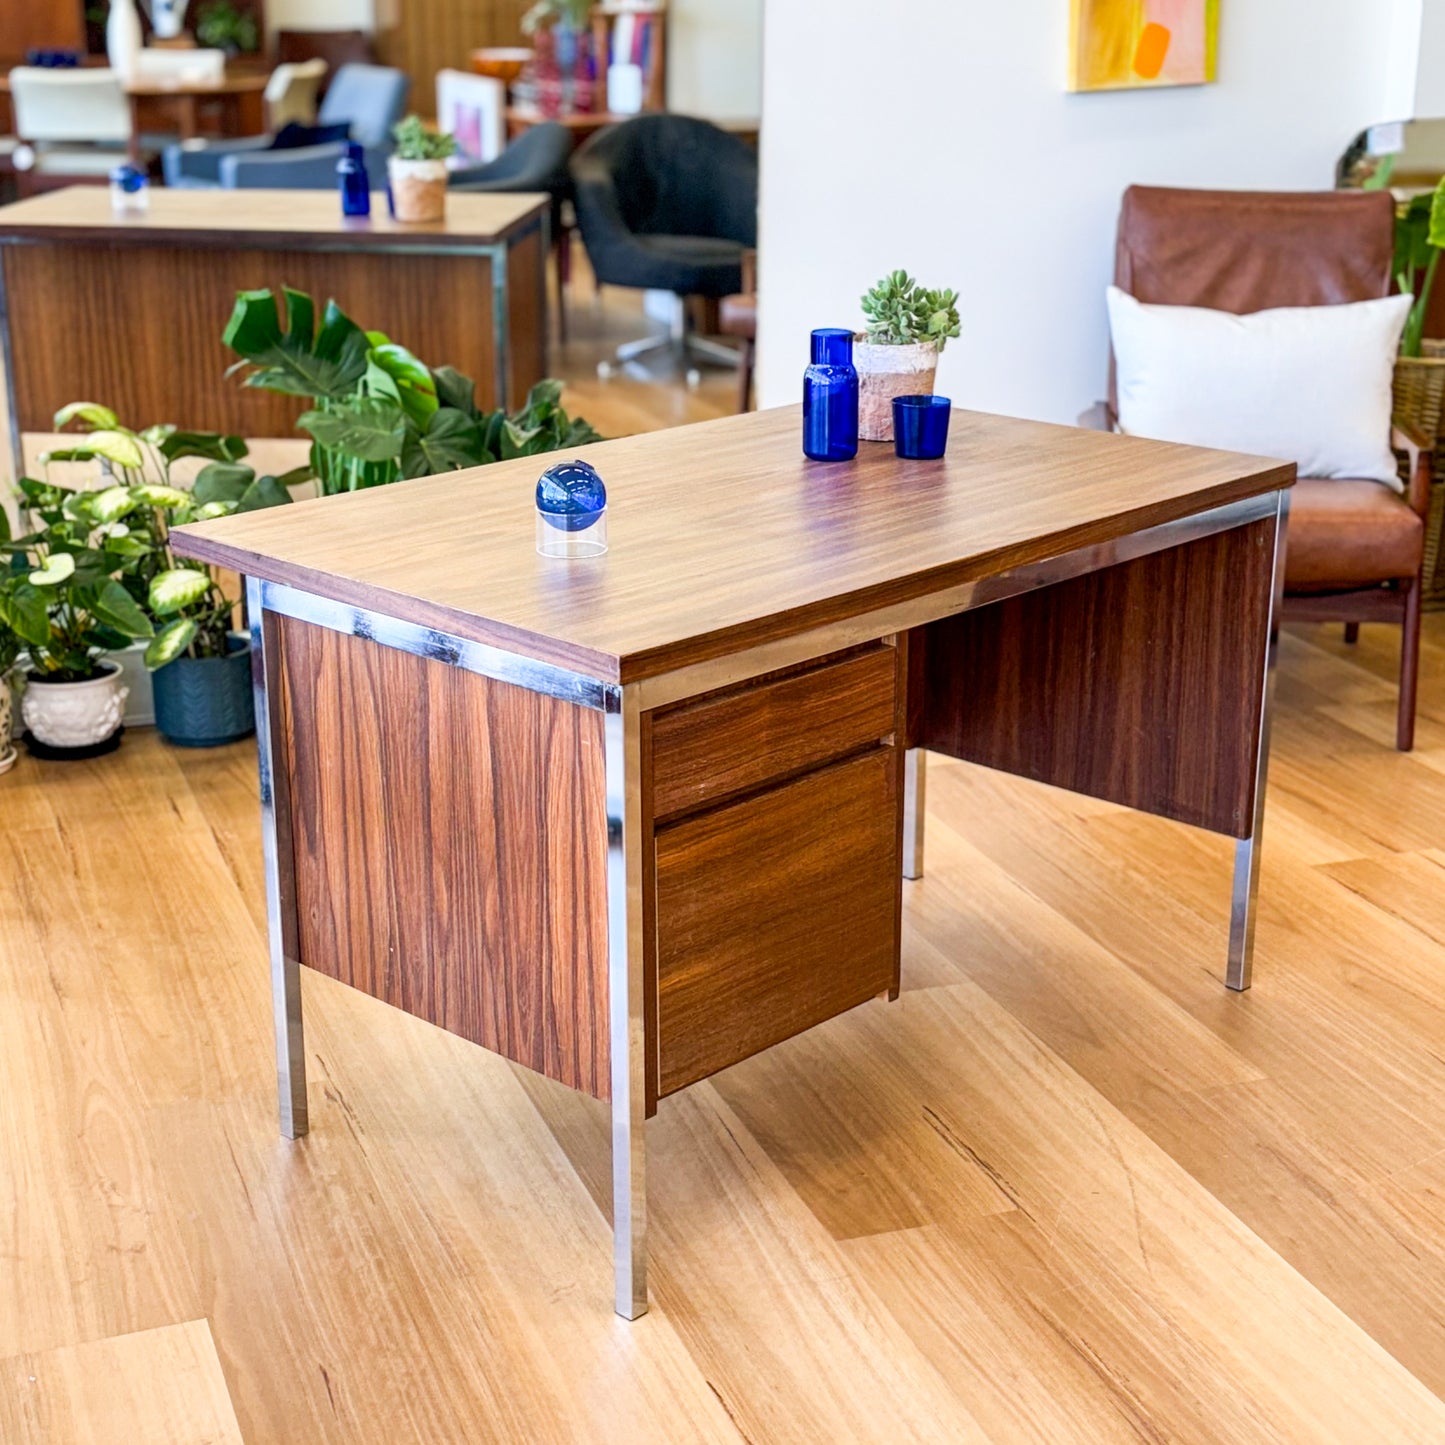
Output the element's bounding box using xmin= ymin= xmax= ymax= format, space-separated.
xmin=652 ymin=643 xmax=899 ymax=819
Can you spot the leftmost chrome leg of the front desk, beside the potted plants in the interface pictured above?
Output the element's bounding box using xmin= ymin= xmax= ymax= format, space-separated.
xmin=246 ymin=578 xmax=306 ymax=1139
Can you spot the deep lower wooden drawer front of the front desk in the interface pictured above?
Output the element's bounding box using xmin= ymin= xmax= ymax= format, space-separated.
xmin=655 ymin=747 xmax=902 ymax=1097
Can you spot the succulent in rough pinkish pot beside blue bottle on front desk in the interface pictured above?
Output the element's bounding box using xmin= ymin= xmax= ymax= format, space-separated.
xmin=853 ymin=270 xmax=959 ymax=442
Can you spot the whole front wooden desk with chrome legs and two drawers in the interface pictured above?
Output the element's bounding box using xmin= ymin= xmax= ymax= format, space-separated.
xmin=176 ymin=409 xmax=1293 ymax=1318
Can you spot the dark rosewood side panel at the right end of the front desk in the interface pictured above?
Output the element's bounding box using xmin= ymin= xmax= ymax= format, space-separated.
xmin=909 ymin=517 xmax=1276 ymax=838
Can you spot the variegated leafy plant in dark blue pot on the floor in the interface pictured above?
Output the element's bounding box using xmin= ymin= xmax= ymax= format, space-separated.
xmin=48 ymin=403 xmax=292 ymax=747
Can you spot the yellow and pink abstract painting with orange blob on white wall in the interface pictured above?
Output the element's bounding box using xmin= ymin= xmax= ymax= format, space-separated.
xmin=1069 ymin=0 xmax=1220 ymax=91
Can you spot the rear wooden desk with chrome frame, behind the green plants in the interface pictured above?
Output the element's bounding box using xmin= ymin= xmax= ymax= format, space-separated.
xmin=0 ymin=186 xmax=551 ymax=473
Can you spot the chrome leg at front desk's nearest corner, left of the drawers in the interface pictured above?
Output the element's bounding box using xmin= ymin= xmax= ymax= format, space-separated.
xmin=605 ymin=688 xmax=647 ymax=1319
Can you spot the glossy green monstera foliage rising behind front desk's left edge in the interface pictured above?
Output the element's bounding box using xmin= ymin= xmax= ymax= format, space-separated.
xmin=223 ymin=289 xmax=601 ymax=496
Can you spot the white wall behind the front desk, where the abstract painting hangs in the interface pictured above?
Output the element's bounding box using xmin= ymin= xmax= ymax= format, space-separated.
xmin=759 ymin=0 xmax=1421 ymax=422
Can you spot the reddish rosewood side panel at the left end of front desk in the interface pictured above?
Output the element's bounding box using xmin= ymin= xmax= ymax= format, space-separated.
xmin=276 ymin=617 xmax=610 ymax=1098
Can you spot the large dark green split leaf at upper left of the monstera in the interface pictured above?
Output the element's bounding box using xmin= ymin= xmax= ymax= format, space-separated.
xmin=221 ymin=289 xmax=370 ymax=400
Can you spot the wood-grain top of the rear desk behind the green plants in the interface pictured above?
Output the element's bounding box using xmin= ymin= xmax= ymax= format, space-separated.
xmin=0 ymin=185 xmax=551 ymax=250
